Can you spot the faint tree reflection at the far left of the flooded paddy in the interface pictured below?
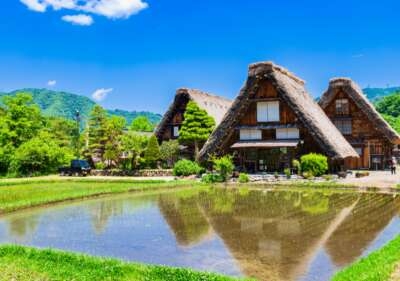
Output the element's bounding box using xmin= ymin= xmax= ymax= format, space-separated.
xmin=7 ymin=215 xmax=39 ymax=239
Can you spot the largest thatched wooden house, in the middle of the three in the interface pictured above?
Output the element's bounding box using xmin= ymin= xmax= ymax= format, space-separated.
xmin=199 ymin=62 xmax=358 ymax=172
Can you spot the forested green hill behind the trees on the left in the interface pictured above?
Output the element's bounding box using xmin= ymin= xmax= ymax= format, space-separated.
xmin=0 ymin=88 xmax=161 ymax=124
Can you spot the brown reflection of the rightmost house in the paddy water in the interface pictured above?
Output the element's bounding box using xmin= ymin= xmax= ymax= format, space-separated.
xmin=326 ymin=194 xmax=400 ymax=266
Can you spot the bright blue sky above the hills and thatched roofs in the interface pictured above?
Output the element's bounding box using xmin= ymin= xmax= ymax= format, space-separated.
xmin=0 ymin=0 xmax=400 ymax=113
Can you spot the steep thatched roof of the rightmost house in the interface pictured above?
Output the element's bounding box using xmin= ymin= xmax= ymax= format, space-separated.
xmin=319 ymin=78 xmax=400 ymax=144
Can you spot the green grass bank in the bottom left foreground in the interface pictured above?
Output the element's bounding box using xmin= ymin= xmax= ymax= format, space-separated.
xmin=0 ymin=246 xmax=250 ymax=281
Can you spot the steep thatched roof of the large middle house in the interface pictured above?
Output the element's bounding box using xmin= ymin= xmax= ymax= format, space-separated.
xmin=200 ymin=62 xmax=358 ymax=161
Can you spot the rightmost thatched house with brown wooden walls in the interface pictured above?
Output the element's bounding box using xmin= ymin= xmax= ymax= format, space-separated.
xmin=319 ymin=78 xmax=400 ymax=170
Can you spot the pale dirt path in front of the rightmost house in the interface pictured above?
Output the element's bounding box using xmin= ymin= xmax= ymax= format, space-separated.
xmin=339 ymin=169 xmax=400 ymax=188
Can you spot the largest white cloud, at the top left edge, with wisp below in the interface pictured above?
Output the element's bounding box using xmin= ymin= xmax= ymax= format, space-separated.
xmin=20 ymin=0 xmax=149 ymax=25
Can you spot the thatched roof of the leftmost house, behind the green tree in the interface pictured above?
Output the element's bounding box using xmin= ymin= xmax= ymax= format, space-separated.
xmin=156 ymin=88 xmax=232 ymax=137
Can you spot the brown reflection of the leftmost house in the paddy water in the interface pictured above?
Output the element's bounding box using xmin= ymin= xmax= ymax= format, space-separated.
xmin=158 ymin=195 xmax=213 ymax=246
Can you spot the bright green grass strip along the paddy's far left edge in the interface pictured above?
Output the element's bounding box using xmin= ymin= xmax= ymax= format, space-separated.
xmin=0 ymin=178 xmax=197 ymax=214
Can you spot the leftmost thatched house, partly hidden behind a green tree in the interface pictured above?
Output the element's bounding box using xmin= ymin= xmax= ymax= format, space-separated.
xmin=155 ymin=88 xmax=232 ymax=155
